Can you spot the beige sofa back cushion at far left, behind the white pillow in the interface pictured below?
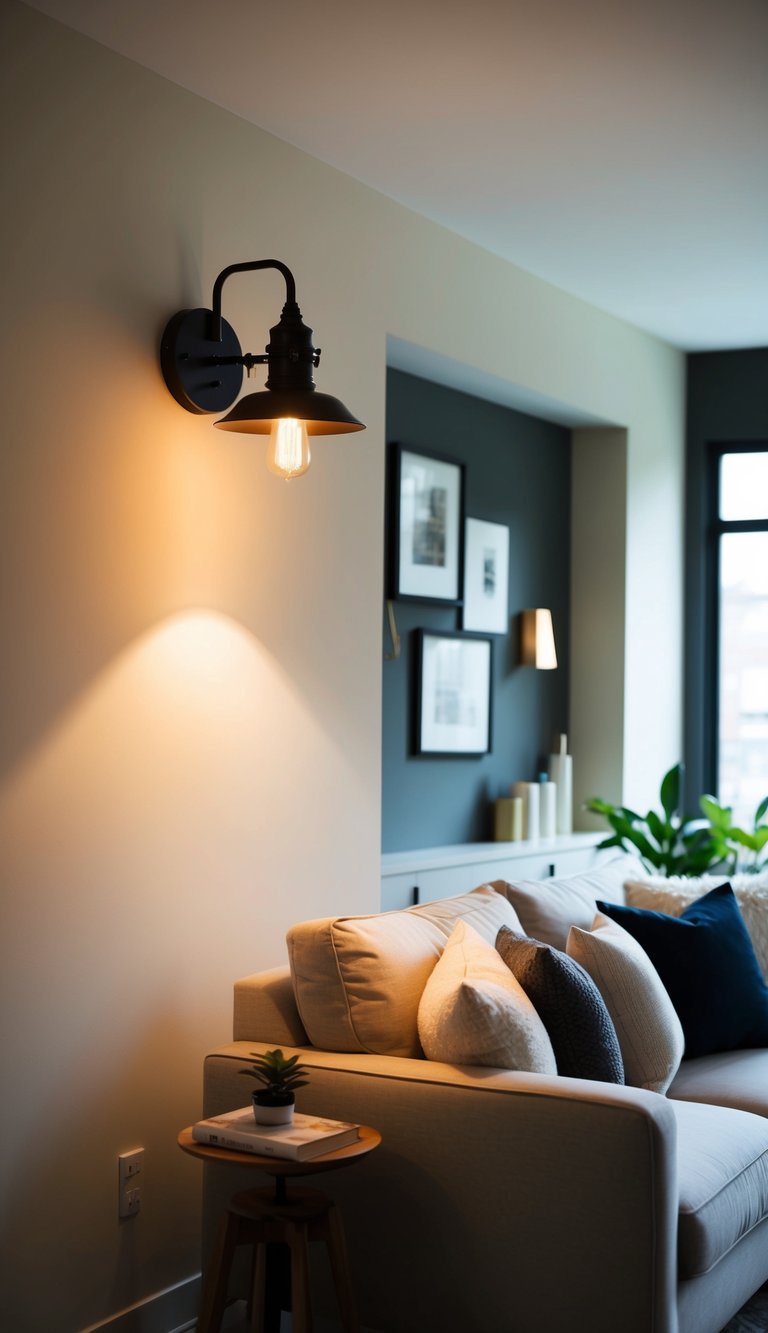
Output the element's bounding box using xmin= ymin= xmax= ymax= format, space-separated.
xmin=288 ymin=884 xmax=520 ymax=1056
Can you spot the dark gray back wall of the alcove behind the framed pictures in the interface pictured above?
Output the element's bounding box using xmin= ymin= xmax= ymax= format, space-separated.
xmin=383 ymin=371 xmax=571 ymax=852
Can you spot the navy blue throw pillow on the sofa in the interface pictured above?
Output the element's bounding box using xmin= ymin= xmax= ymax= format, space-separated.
xmin=597 ymin=884 xmax=768 ymax=1060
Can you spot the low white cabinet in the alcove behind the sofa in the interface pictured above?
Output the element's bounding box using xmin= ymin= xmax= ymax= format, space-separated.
xmin=381 ymin=833 xmax=604 ymax=912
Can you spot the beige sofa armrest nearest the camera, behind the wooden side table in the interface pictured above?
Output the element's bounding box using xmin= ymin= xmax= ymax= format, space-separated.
xmin=205 ymin=1042 xmax=677 ymax=1333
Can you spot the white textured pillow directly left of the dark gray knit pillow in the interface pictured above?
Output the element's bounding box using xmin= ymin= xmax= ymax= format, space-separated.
xmin=419 ymin=921 xmax=557 ymax=1074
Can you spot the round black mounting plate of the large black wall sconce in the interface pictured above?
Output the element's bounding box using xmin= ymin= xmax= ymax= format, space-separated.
xmin=160 ymin=309 xmax=243 ymax=415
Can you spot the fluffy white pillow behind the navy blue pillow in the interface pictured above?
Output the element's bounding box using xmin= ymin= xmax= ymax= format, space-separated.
xmin=624 ymin=872 xmax=768 ymax=982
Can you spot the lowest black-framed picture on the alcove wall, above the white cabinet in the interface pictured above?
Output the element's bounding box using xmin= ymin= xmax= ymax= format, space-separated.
xmin=416 ymin=629 xmax=493 ymax=754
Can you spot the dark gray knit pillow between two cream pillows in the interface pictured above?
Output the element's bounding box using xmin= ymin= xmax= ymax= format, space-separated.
xmin=496 ymin=925 xmax=624 ymax=1084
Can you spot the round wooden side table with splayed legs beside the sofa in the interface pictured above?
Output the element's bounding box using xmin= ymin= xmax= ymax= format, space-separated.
xmin=179 ymin=1125 xmax=381 ymax=1333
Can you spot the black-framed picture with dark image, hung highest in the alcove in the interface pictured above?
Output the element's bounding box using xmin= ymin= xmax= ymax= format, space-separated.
xmin=391 ymin=444 xmax=464 ymax=605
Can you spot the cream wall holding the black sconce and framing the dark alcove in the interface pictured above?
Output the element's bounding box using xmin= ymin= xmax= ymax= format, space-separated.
xmin=0 ymin=0 xmax=683 ymax=1333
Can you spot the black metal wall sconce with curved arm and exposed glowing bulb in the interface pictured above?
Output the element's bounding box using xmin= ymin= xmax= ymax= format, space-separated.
xmin=160 ymin=259 xmax=365 ymax=479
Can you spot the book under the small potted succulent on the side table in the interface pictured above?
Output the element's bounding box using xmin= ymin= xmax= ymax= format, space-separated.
xmin=192 ymin=1106 xmax=360 ymax=1162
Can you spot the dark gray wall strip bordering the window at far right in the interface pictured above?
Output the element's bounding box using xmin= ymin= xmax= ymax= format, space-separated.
xmin=684 ymin=348 xmax=768 ymax=808
